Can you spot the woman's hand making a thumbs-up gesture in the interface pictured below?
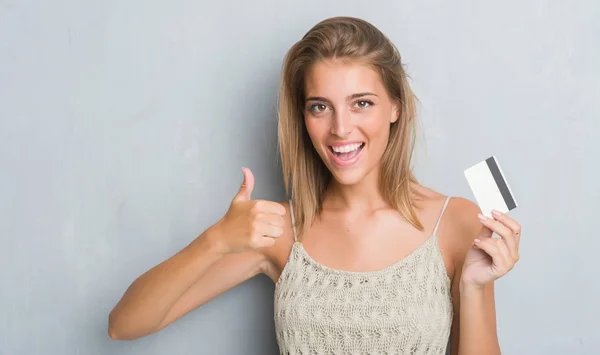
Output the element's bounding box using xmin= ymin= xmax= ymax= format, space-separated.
xmin=210 ymin=168 xmax=285 ymax=253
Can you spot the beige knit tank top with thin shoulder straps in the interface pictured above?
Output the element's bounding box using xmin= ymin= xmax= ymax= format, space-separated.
xmin=274 ymin=197 xmax=453 ymax=355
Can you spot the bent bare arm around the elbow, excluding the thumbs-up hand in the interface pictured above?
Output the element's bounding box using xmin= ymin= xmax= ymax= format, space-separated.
xmin=108 ymin=229 xmax=266 ymax=340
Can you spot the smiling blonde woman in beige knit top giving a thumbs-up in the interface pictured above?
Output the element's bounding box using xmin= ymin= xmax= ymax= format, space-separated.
xmin=109 ymin=17 xmax=520 ymax=355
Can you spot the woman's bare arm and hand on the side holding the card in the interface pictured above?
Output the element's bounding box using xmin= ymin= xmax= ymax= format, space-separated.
xmin=449 ymin=199 xmax=520 ymax=355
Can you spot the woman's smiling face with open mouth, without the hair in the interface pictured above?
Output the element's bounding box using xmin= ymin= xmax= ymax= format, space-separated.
xmin=304 ymin=60 xmax=399 ymax=185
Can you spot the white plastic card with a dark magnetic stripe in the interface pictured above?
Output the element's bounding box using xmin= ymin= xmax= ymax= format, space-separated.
xmin=465 ymin=156 xmax=517 ymax=217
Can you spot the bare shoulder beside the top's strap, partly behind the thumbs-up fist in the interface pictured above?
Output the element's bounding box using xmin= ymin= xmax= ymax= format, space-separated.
xmin=261 ymin=201 xmax=294 ymax=282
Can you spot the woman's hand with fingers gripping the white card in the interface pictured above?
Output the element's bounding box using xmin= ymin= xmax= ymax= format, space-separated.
xmin=461 ymin=211 xmax=521 ymax=287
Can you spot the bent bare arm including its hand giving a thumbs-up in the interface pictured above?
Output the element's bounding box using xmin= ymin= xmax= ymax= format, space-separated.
xmin=108 ymin=169 xmax=291 ymax=340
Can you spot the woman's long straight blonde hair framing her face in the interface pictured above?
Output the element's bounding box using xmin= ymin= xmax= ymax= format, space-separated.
xmin=278 ymin=17 xmax=423 ymax=236
